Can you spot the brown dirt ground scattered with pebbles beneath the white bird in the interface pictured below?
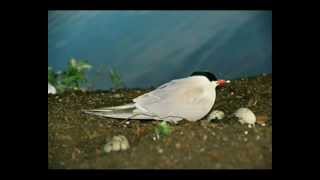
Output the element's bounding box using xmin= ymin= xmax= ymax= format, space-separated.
xmin=48 ymin=75 xmax=272 ymax=169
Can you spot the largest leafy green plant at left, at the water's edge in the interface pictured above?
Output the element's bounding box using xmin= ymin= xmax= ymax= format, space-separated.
xmin=48 ymin=58 xmax=92 ymax=92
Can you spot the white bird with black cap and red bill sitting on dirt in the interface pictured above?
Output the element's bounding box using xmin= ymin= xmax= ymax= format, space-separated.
xmin=85 ymin=72 xmax=230 ymax=123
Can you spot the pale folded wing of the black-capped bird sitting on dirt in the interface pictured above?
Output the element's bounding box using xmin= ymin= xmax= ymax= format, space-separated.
xmin=134 ymin=78 xmax=211 ymax=121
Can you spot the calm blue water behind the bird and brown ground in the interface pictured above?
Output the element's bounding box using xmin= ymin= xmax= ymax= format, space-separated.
xmin=48 ymin=11 xmax=272 ymax=89
